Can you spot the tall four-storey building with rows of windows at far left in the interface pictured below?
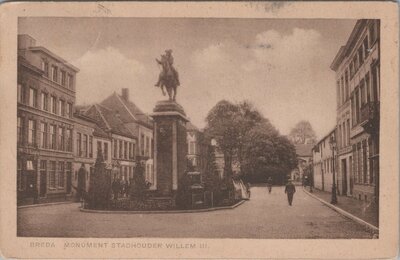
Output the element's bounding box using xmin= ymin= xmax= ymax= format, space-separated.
xmin=17 ymin=35 xmax=79 ymax=203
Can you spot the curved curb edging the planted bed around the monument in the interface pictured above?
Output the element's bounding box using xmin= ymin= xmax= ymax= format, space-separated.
xmin=79 ymin=200 xmax=245 ymax=214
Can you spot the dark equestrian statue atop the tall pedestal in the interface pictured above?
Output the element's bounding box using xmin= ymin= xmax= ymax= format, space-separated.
xmin=154 ymin=50 xmax=180 ymax=101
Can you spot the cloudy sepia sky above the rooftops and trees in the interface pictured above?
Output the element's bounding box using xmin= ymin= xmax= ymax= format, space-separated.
xmin=19 ymin=18 xmax=356 ymax=137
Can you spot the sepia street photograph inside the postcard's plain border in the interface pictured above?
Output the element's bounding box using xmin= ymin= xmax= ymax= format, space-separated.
xmin=14 ymin=17 xmax=381 ymax=239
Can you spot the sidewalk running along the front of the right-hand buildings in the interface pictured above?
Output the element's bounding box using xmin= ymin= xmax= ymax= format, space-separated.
xmin=306 ymin=187 xmax=379 ymax=227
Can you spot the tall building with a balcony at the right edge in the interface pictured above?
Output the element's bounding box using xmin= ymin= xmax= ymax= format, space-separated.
xmin=331 ymin=19 xmax=380 ymax=201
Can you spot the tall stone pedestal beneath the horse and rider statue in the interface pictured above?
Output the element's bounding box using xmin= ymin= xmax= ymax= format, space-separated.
xmin=151 ymin=101 xmax=188 ymax=196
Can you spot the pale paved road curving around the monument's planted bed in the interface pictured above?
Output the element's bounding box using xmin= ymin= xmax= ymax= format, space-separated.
xmin=18 ymin=187 xmax=372 ymax=238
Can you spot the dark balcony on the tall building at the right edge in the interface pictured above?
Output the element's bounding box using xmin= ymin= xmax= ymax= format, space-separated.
xmin=360 ymin=102 xmax=380 ymax=134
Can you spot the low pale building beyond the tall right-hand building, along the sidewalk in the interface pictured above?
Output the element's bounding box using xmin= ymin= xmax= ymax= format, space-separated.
xmin=312 ymin=128 xmax=337 ymax=192
